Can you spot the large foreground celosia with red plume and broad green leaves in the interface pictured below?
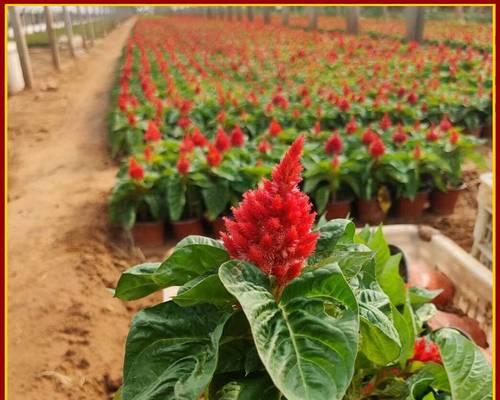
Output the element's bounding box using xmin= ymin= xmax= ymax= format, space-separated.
xmin=114 ymin=139 xmax=492 ymax=400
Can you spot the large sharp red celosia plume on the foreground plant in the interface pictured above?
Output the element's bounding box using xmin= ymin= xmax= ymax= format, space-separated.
xmin=221 ymin=136 xmax=318 ymax=286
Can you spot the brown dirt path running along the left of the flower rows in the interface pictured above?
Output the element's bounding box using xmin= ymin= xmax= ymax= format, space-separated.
xmin=8 ymin=17 xmax=158 ymax=400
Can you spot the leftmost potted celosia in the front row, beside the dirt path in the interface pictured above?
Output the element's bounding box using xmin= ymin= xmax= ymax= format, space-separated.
xmin=109 ymin=157 xmax=166 ymax=246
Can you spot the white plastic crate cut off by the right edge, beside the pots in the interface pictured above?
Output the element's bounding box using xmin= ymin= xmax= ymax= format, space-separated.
xmin=471 ymin=172 xmax=493 ymax=269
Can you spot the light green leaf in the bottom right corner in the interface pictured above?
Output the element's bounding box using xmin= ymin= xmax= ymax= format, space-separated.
xmin=433 ymin=328 xmax=493 ymax=400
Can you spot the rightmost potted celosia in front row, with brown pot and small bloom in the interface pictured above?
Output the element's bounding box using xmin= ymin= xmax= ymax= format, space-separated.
xmin=431 ymin=129 xmax=484 ymax=215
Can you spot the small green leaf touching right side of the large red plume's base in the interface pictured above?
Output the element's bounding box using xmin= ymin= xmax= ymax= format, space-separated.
xmin=308 ymin=219 xmax=356 ymax=264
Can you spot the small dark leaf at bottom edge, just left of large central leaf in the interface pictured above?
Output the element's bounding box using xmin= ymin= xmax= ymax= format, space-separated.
xmin=215 ymin=376 xmax=281 ymax=400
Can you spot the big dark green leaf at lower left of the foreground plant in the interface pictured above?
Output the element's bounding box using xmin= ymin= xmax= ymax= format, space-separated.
xmin=122 ymin=302 xmax=230 ymax=400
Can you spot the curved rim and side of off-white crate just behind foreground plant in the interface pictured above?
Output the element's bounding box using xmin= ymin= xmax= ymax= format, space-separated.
xmin=383 ymin=225 xmax=493 ymax=346
